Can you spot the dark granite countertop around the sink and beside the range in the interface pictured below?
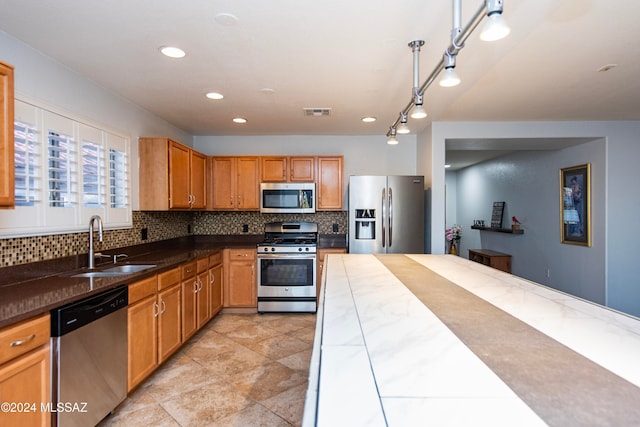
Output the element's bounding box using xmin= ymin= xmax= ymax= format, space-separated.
xmin=0 ymin=234 xmax=346 ymax=327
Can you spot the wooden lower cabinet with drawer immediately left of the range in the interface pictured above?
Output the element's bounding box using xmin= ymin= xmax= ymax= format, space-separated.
xmin=224 ymin=248 xmax=258 ymax=308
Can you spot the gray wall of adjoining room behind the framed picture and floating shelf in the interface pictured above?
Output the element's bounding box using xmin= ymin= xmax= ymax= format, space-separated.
xmin=456 ymin=140 xmax=606 ymax=304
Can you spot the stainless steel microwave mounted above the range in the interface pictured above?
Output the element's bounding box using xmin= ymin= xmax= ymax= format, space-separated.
xmin=260 ymin=182 xmax=316 ymax=213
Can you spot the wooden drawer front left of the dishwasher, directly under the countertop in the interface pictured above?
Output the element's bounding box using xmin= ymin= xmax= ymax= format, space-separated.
xmin=0 ymin=313 xmax=51 ymax=365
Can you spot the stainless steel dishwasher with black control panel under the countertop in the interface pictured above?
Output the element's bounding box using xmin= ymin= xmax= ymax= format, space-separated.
xmin=51 ymin=285 xmax=128 ymax=427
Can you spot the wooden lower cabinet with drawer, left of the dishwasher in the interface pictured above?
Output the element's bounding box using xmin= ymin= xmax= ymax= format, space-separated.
xmin=0 ymin=314 xmax=51 ymax=427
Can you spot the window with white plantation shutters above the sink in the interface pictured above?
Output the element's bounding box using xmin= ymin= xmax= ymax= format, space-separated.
xmin=0 ymin=98 xmax=132 ymax=237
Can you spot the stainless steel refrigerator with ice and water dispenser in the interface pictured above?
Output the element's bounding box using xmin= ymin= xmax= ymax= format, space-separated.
xmin=349 ymin=176 xmax=425 ymax=254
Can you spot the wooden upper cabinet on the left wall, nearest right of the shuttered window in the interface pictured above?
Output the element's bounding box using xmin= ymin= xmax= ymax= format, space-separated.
xmin=138 ymin=138 xmax=207 ymax=210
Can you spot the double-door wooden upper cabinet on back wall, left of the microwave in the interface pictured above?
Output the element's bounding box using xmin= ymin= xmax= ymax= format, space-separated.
xmin=208 ymin=156 xmax=260 ymax=210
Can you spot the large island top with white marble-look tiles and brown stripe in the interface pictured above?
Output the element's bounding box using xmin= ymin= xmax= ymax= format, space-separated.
xmin=303 ymin=254 xmax=640 ymax=427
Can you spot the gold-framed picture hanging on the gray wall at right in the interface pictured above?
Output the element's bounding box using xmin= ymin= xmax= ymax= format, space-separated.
xmin=560 ymin=163 xmax=591 ymax=246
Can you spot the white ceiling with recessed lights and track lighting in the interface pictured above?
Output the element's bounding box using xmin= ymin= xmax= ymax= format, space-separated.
xmin=0 ymin=0 xmax=640 ymax=166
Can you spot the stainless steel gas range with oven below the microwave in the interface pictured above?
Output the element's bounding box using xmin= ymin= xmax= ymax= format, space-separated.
xmin=257 ymin=222 xmax=318 ymax=313
